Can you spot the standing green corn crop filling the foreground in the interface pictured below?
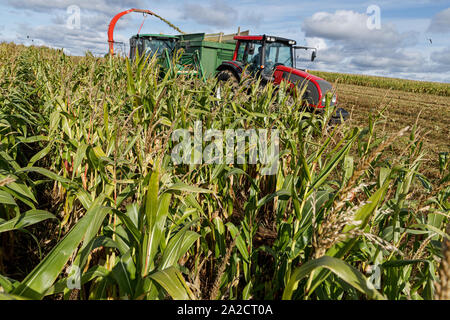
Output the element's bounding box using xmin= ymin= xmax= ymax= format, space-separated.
xmin=0 ymin=44 xmax=450 ymax=300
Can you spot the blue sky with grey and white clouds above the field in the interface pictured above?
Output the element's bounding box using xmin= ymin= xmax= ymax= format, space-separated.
xmin=0 ymin=0 xmax=450 ymax=83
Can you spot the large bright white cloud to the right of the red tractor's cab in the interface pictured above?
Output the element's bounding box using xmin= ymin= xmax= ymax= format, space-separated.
xmin=302 ymin=10 xmax=450 ymax=81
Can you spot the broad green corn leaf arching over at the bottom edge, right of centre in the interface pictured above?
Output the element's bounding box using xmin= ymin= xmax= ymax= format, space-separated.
xmin=283 ymin=256 xmax=385 ymax=300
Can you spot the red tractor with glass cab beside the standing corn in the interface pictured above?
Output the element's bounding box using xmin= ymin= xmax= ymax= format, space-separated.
xmin=217 ymin=35 xmax=348 ymax=120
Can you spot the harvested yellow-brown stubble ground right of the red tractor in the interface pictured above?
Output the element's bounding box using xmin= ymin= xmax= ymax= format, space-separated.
xmin=336 ymin=83 xmax=450 ymax=178
